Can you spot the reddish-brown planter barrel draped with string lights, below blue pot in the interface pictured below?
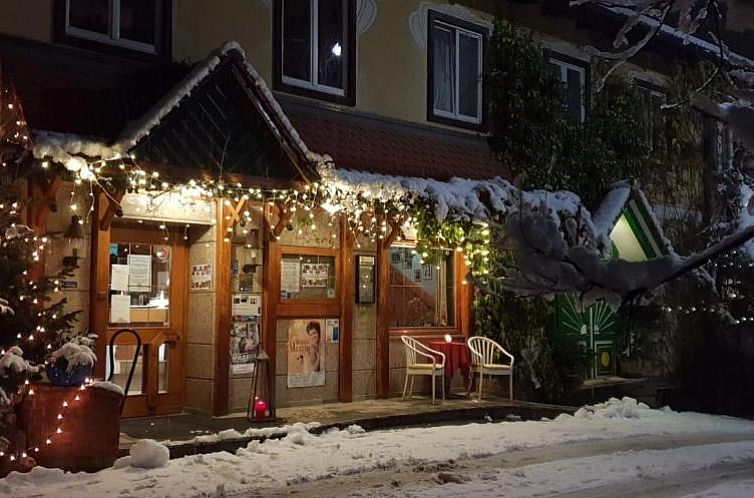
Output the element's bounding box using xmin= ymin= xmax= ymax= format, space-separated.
xmin=18 ymin=384 xmax=123 ymax=472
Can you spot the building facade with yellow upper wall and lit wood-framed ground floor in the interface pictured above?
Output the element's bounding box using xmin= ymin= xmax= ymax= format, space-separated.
xmin=0 ymin=0 xmax=743 ymax=416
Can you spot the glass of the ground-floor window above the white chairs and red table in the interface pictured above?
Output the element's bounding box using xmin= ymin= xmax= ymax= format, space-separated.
xmin=388 ymin=247 xmax=456 ymax=328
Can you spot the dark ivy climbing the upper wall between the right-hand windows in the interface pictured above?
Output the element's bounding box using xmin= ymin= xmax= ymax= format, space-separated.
xmin=487 ymin=21 xmax=649 ymax=208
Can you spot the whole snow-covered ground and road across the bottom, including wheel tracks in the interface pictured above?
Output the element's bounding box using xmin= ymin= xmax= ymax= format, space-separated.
xmin=0 ymin=399 xmax=754 ymax=498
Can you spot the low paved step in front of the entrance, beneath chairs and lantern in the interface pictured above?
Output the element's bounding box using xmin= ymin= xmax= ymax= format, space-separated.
xmin=120 ymin=397 xmax=576 ymax=458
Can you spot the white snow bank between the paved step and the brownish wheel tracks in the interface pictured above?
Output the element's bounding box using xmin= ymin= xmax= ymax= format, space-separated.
xmin=8 ymin=398 xmax=754 ymax=498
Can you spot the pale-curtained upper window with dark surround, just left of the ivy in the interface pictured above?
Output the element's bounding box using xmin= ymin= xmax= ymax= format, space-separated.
xmin=427 ymin=11 xmax=485 ymax=125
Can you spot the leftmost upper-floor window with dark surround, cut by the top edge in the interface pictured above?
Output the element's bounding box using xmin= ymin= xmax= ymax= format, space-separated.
xmin=59 ymin=0 xmax=170 ymax=54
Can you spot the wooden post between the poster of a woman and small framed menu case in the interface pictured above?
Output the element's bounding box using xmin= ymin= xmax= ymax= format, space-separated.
xmin=338 ymin=215 xmax=356 ymax=403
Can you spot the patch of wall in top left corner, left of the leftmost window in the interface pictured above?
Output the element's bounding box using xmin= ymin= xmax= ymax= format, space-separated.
xmin=0 ymin=0 xmax=53 ymax=43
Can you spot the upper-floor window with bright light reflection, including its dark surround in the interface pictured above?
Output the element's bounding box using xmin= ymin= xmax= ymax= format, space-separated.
xmin=276 ymin=0 xmax=355 ymax=104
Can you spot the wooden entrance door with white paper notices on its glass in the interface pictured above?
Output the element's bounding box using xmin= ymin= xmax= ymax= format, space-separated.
xmin=100 ymin=225 xmax=188 ymax=417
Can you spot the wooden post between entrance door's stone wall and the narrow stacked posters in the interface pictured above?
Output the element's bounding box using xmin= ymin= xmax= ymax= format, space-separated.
xmin=212 ymin=199 xmax=232 ymax=415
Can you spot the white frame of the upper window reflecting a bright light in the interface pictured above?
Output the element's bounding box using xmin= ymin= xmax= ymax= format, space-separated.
xmin=280 ymin=0 xmax=351 ymax=97
